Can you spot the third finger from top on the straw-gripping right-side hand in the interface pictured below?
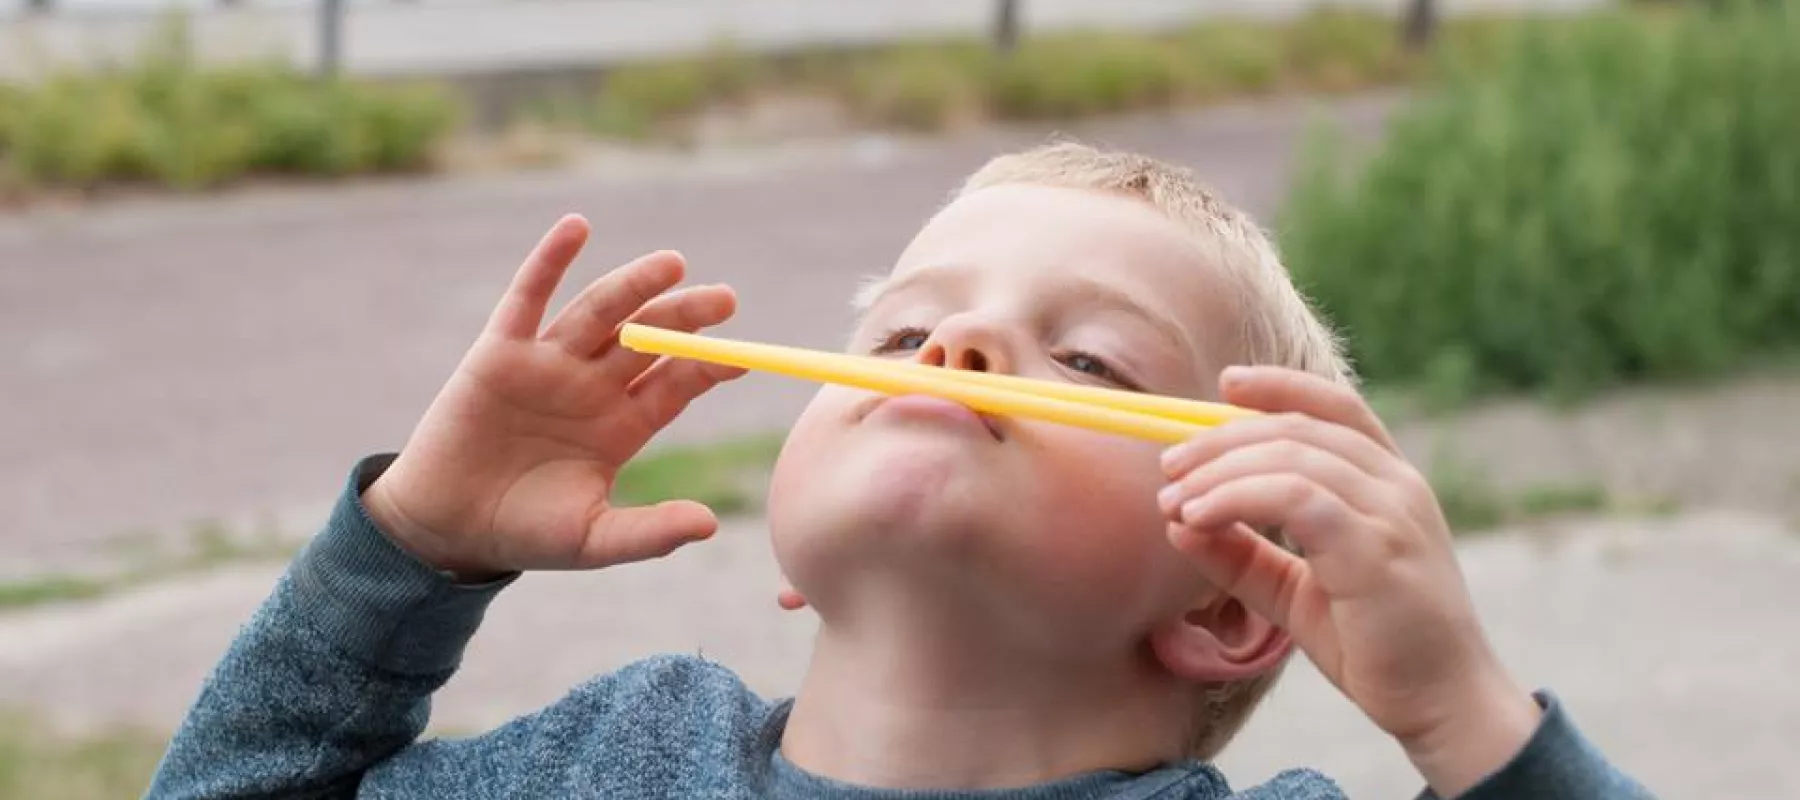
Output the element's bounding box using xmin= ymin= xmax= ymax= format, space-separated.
xmin=1156 ymin=431 xmax=1388 ymax=517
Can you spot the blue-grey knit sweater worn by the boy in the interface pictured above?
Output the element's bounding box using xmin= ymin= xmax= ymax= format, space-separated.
xmin=148 ymin=456 xmax=1649 ymax=800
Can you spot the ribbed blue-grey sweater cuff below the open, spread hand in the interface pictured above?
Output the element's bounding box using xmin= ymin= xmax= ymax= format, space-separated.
xmin=292 ymin=454 xmax=518 ymax=674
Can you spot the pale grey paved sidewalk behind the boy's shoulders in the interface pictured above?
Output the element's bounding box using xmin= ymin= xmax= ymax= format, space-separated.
xmin=0 ymin=512 xmax=1800 ymax=798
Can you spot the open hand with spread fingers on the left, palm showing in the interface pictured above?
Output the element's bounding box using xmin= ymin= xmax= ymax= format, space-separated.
xmin=362 ymin=214 xmax=742 ymax=580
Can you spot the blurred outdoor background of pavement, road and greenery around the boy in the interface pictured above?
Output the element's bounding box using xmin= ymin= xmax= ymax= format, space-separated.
xmin=0 ymin=0 xmax=1800 ymax=798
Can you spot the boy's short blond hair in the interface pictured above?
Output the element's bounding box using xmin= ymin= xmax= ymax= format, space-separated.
xmin=952 ymin=141 xmax=1355 ymax=759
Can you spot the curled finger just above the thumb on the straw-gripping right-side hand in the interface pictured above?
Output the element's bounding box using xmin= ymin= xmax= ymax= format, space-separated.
xmin=1181 ymin=472 xmax=1384 ymax=560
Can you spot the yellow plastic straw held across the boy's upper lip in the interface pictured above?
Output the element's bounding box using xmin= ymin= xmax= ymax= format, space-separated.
xmin=619 ymin=323 xmax=1255 ymax=443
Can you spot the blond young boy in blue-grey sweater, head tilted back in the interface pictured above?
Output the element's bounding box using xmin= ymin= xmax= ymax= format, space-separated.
xmin=149 ymin=144 xmax=1647 ymax=798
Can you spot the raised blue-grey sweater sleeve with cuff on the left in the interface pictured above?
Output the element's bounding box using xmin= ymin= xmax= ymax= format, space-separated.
xmin=146 ymin=456 xmax=517 ymax=798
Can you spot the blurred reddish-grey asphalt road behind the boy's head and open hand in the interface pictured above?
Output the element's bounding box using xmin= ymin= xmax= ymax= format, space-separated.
xmin=0 ymin=97 xmax=1391 ymax=573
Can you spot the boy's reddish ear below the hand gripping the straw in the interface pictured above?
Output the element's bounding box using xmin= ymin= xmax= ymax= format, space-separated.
xmin=1150 ymin=589 xmax=1294 ymax=683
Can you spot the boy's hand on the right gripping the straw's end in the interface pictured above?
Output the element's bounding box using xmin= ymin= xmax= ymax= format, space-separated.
xmin=1159 ymin=368 xmax=1539 ymax=796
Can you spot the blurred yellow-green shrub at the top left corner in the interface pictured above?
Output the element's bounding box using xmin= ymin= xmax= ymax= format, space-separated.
xmin=0 ymin=23 xmax=457 ymax=189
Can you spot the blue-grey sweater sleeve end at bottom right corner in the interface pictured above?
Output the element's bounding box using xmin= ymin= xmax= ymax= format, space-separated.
xmin=1418 ymin=692 xmax=1652 ymax=800
